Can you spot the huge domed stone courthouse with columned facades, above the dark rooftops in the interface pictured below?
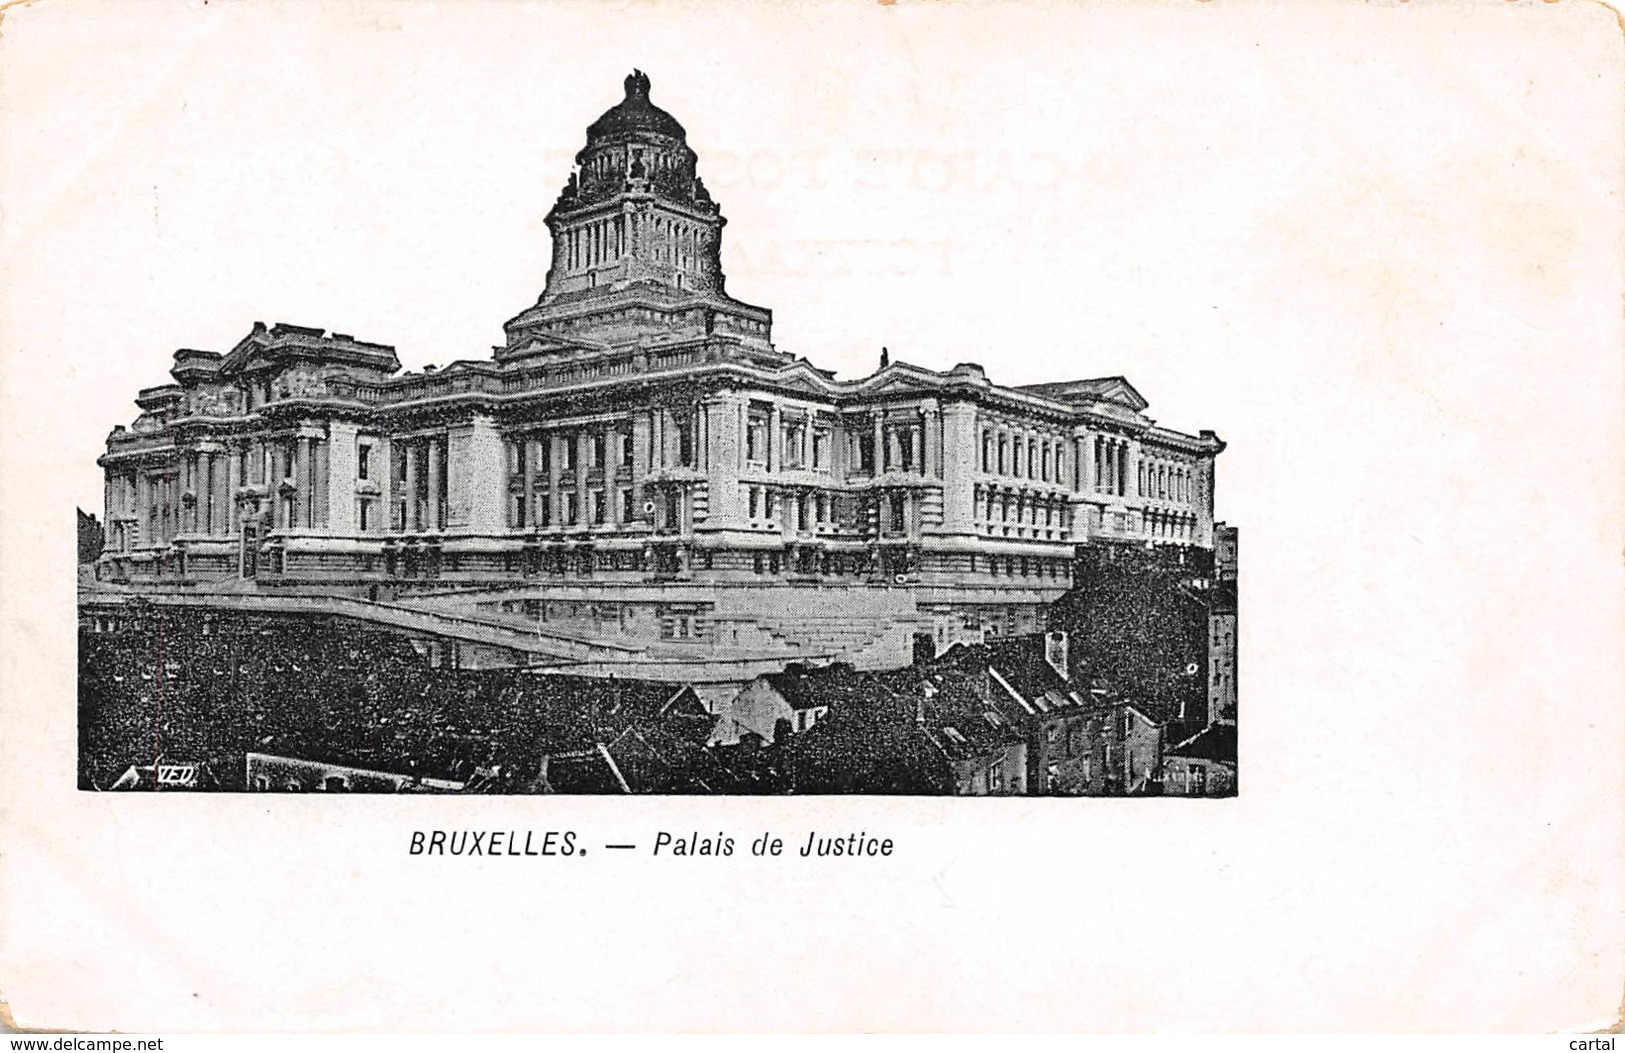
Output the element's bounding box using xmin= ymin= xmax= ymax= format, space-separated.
xmin=99 ymin=72 xmax=1224 ymax=676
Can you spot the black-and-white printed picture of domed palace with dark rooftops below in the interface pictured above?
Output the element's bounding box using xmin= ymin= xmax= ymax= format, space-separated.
xmin=80 ymin=70 xmax=1238 ymax=796
